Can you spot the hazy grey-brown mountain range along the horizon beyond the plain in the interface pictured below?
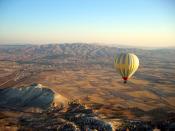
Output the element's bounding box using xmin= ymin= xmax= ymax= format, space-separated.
xmin=0 ymin=43 xmax=175 ymax=64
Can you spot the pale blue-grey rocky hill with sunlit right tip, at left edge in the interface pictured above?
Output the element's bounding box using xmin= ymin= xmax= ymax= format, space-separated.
xmin=0 ymin=84 xmax=66 ymax=109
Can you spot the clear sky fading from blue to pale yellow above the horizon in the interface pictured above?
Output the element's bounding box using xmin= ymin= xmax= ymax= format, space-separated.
xmin=0 ymin=0 xmax=175 ymax=46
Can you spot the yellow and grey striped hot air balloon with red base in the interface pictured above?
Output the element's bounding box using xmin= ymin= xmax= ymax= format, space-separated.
xmin=114 ymin=53 xmax=139 ymax=83
